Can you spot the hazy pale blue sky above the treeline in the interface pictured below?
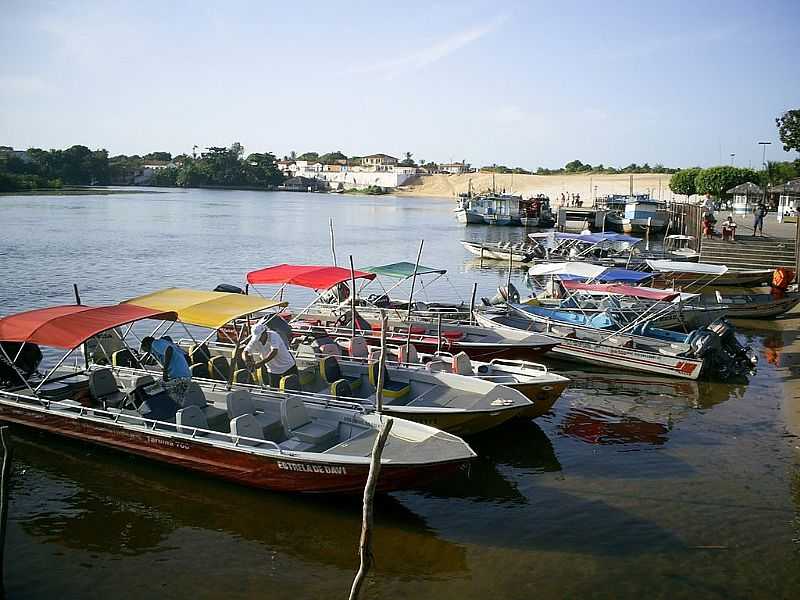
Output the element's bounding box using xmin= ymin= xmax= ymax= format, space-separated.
xmin=0 ymin=0 xmax=800 ymax=168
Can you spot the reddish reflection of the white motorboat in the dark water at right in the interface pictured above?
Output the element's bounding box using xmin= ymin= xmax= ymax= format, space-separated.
xmin=559 ymin=370 xmax=746 ymax=445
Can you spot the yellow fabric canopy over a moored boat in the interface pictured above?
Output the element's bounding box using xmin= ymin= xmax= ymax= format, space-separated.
xmin=122 ymin=288 xmax=288 ymax=329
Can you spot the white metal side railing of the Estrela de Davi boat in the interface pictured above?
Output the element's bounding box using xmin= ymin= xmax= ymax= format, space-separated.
xmin=0 ymin=390 xmax=284 ymax=454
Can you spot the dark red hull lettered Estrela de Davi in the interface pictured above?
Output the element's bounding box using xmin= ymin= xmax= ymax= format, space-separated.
xmin=0 ymin=403 xmax=464 ymax=494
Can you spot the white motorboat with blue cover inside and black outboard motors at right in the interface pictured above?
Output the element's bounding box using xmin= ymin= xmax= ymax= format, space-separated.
xmin=476 ymin=304 xmax=755 ymax=380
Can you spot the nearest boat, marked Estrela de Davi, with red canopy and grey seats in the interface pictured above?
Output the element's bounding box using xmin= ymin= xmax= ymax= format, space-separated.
xmin=0 ymin=292 xmax=475 ymax=493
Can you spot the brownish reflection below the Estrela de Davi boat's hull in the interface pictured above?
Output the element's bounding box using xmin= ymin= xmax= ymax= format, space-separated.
xmin=12 ymin=429 xmax=468 ymax=579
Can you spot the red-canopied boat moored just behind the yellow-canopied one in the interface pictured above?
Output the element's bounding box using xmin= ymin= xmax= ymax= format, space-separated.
xmin=242 ymin=264 xmax=554 ymax=360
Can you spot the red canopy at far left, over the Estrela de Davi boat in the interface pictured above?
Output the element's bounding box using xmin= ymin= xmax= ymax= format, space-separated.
xmin=0 ymin=304 xmax=177 ymax=350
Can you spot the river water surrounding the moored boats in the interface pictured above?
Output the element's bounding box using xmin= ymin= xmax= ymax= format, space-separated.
xmin=0 ymin=190 xmax=800 ymax=600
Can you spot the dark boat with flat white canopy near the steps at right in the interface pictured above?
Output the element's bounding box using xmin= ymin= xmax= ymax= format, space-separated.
xmin=645 ymin=260 xmax=773 ymax=287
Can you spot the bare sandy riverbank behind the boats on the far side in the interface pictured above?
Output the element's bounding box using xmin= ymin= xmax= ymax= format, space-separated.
xmin=394 ymin=173 xmax=674 ymax=206
